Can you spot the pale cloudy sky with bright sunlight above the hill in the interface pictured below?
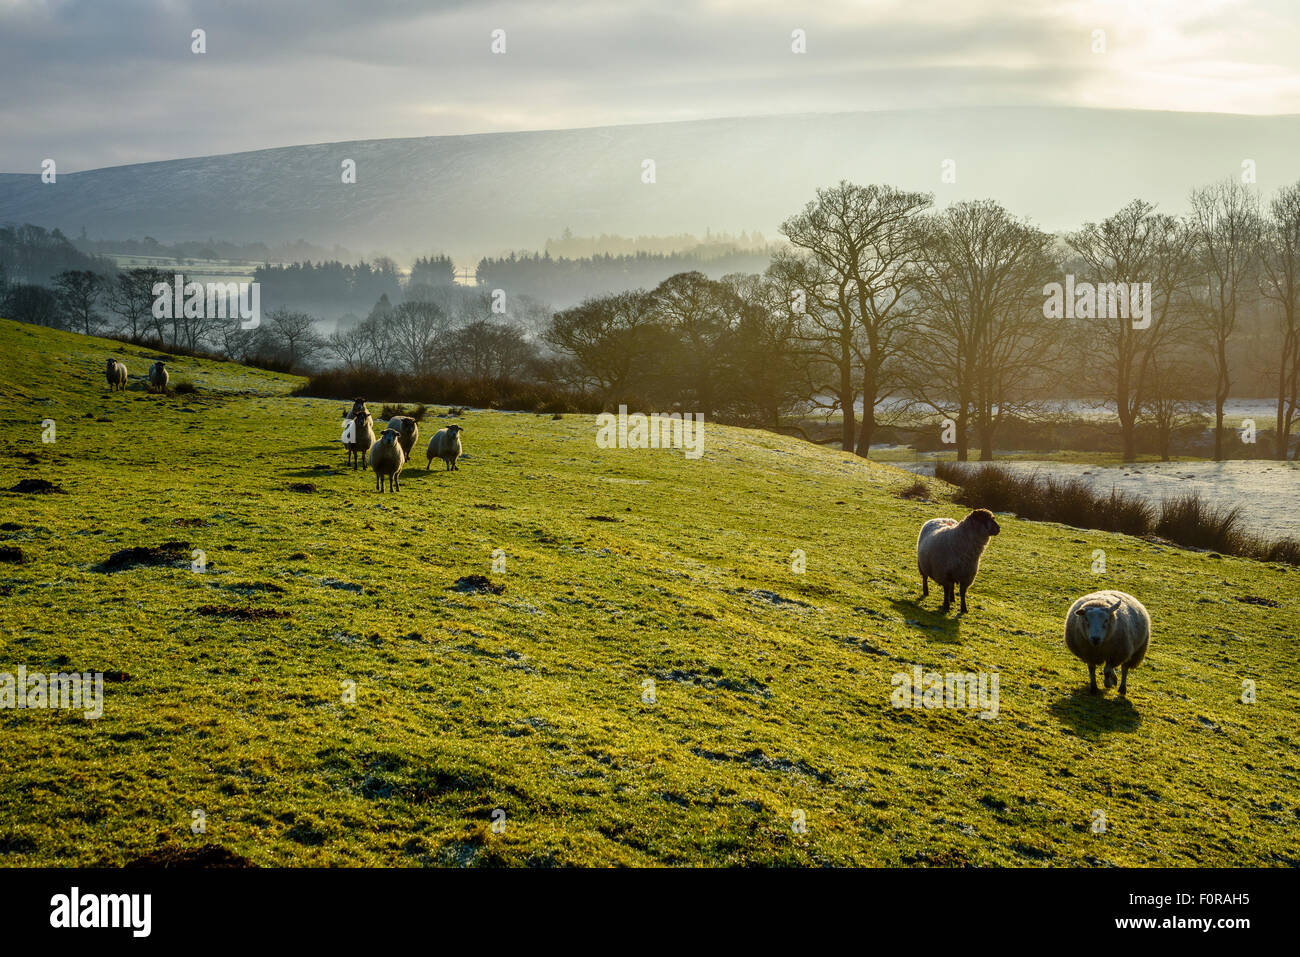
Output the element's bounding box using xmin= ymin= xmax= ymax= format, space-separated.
xmin=0 ymin=0 xmax=1300 ymax=173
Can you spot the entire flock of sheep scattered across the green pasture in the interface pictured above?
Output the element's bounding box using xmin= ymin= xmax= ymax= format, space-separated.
xmin=98 ymin=359 xmax=1151 ymax=694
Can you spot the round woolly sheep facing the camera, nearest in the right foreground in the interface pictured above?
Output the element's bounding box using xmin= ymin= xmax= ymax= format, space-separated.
xmin=1065 ymin=590 xmax=1151 ymax=696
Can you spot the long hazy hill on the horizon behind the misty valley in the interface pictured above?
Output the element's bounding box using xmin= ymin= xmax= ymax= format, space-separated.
xmin=0 ymin=108 xmax=1300 ymax=264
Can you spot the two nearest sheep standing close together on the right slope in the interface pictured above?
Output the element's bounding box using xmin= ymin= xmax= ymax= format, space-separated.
xmin=917 ymin=508 xmax=1151 ymax=694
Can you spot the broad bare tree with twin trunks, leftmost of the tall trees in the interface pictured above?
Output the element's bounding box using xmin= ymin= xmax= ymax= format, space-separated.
xmin=772 ymin=181 xmax=933 ymax=456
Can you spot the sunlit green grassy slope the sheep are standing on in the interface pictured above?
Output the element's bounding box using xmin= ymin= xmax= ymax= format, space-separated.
xmin=0 ymin=315 xmax=1300 ymax=866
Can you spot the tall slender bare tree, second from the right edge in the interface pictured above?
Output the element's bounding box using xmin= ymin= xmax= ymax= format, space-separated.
xmin=1191 ymin=179 xmax=1261 ymax=462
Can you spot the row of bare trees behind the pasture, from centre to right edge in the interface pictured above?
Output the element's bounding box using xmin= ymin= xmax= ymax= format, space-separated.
xmin=547 ymin=182 xmax=1300 ymax=460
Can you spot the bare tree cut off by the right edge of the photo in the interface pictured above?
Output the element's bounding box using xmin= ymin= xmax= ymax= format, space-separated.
xmin=1260 ymin=182 xmax=1300 ymax=459
